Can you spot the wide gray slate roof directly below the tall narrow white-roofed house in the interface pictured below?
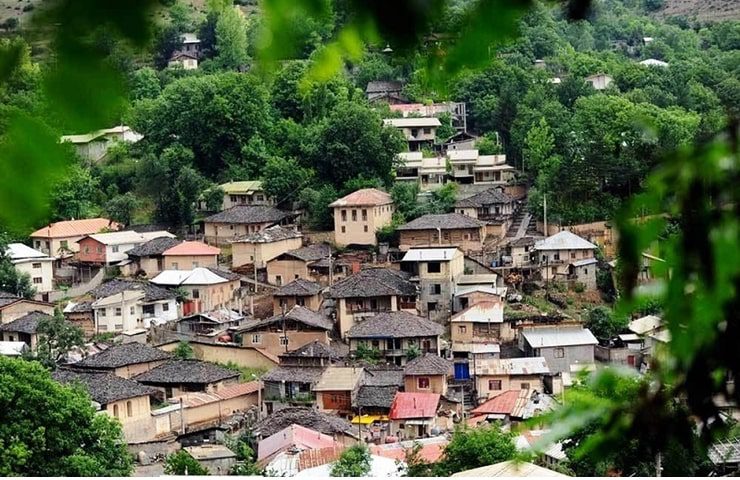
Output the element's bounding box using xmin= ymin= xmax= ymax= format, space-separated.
xmin=347 ymin=311 xmax=444 ymax=338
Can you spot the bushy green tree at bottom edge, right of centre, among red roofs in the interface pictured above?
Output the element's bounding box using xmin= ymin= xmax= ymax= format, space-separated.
xmin=438 ymin=424 xmax=516 ymax=476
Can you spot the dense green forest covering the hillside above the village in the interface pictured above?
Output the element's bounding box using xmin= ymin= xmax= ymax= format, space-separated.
xmin=0 ymin=0 xmax=740 ymax=233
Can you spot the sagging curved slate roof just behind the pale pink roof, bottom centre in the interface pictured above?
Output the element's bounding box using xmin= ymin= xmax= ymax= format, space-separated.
xmin=252 ymin=407 xmax=352 ymax=438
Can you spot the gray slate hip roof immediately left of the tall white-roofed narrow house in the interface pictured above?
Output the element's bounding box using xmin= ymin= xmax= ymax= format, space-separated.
xmin=329 ymin=268 xmax=417 ymax=298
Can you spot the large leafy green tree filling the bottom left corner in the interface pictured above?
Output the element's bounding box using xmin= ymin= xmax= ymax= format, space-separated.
xmin=0 ymin=357 xmax=133 ymax=477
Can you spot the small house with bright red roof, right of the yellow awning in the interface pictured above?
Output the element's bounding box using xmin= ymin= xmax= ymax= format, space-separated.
xmin=388 ymin=392 xmax=440 ymax=439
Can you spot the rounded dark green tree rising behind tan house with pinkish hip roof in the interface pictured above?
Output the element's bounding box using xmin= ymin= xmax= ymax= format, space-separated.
xmin=313 ymin=103 xmax=405 ymax=188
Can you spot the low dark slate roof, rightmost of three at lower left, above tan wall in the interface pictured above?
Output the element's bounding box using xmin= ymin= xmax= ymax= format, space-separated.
xmin=134 ymin=360 xmax=239 ymax=384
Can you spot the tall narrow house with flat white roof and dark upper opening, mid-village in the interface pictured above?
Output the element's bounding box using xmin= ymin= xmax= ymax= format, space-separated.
xmin=401 ymin=247 xmax=465 ymax=319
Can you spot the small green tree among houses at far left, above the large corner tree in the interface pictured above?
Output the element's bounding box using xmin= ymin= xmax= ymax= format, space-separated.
xmin=32 ymin=308 xmax=85 ymax=370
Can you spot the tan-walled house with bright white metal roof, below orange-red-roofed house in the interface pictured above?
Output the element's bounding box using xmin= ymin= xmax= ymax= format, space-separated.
xmin=151 ymin=267 xmax=241 ymax=315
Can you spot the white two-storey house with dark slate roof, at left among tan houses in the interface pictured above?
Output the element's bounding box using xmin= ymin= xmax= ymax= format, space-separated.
xmin=90 ymin=279 xmax=178 ymax=333
